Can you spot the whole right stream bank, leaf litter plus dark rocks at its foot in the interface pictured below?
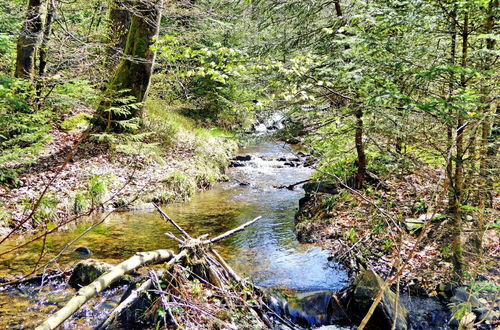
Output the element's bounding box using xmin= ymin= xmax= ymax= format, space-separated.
xmin=295 ymin=173 xmax=500 ymax=329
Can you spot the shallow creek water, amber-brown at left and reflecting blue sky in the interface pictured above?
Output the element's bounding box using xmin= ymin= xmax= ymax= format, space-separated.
xmin=0 ymin=142 xmax=347 ymax=328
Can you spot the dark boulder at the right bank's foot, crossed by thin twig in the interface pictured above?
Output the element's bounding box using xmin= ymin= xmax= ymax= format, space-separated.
xmin=349 ymin=269 xmax=409 ymax=330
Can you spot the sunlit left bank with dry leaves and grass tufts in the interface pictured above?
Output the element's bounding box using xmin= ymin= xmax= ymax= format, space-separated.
xmin=0 ymin=105 xmax=237 ymax=234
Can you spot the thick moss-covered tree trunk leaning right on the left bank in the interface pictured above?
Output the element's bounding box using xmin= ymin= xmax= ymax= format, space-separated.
xmin=96 ymin=0 xmax=161 ymax=131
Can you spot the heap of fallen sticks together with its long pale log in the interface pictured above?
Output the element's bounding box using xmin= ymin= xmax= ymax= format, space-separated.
xmin=36 ymin=210 xmax=272 ymax=330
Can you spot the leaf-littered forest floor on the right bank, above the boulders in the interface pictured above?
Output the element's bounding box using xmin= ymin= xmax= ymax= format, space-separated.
xmin=296 ymin=165 xmax=500 ymax=296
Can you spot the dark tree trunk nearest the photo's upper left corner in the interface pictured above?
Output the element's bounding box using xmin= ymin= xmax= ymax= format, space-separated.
xmin=14 ymin=0 xmax=43 ymax=80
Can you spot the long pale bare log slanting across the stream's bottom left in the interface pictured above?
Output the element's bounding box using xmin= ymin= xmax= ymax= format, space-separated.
xmin=36 ymin=250 xmax=174 ymax=330
